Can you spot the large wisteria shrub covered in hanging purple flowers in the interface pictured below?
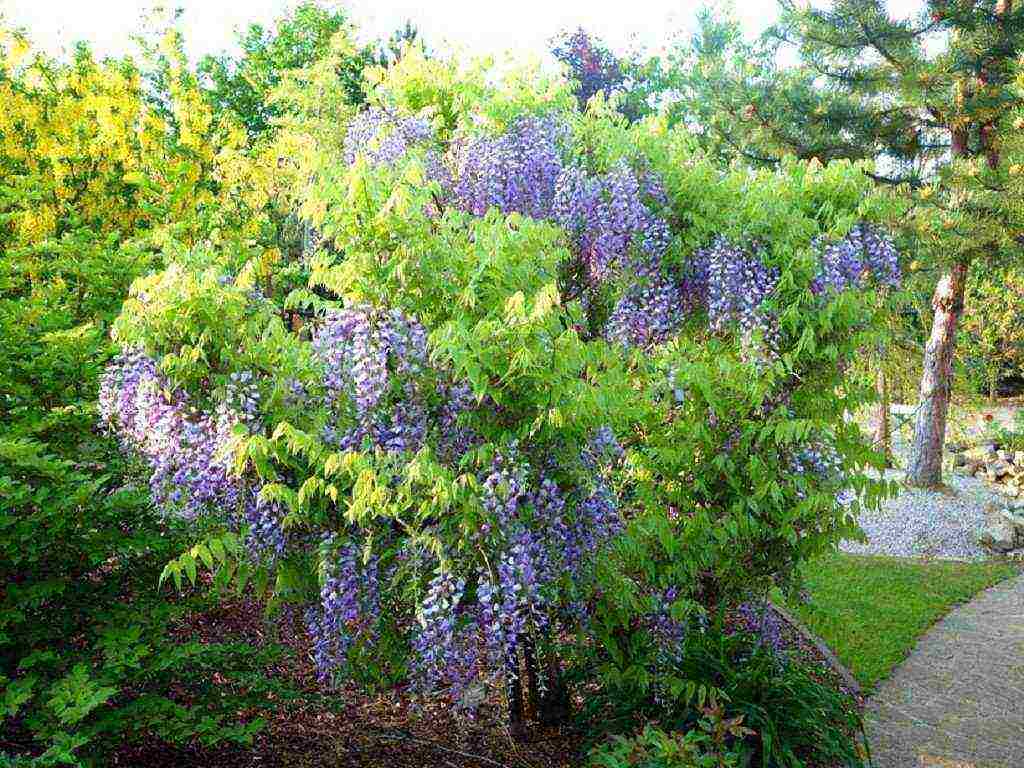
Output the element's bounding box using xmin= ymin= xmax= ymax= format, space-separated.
xmin=101 ymin=61 xmax=898 ymax=727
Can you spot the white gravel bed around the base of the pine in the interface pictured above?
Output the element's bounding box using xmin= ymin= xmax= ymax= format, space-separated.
xmin=840 ymin=472 xmax=1006 ymax=560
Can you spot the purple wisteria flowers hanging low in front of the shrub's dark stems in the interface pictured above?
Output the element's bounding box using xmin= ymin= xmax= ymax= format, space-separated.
xmin=397 ymin=430 xmax=623 ymax=711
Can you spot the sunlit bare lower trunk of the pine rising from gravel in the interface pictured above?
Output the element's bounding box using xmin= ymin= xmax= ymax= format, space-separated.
xmin=906 ymin=262 xmax=967 ymax=487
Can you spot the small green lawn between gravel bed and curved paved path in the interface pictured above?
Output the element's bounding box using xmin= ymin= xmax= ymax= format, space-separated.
xmin=793 ymin=553 xmax=1020 ymax=691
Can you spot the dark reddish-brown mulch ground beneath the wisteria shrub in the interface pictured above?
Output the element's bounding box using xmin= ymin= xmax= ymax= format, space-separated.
xmin=6 ymin=600 xmax=862 ymax=768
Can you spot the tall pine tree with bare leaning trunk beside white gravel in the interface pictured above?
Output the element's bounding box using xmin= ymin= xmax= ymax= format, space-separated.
xmin=679 ymin=0 xmax=1024 ymax=485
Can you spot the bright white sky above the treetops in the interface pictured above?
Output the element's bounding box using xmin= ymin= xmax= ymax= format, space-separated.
xmin=0 ymin=0 xmax=920 ymax=64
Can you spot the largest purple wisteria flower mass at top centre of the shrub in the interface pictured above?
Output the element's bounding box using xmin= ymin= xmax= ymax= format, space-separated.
xmin=450 ymin=117 xmax=693 ymax=346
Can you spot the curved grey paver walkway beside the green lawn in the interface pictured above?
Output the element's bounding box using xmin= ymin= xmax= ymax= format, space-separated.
xmin=866 ymin=577 xmax=1024 ymax=768
